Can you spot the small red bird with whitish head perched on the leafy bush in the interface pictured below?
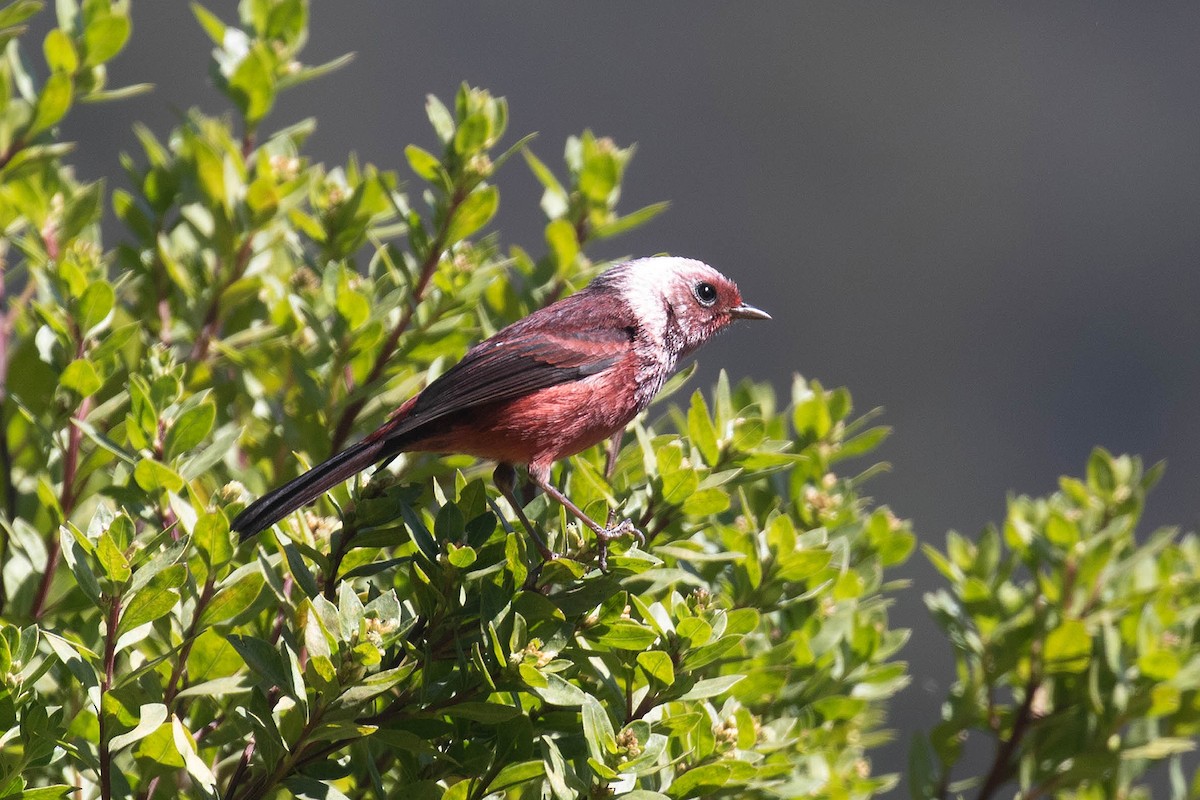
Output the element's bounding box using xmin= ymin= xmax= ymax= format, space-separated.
xmin=232 ymin=255 xmax=770 ymax=569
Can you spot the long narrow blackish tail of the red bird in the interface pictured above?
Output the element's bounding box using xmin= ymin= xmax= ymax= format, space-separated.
xmin=230 ymin=438 xmax=388 ymax=541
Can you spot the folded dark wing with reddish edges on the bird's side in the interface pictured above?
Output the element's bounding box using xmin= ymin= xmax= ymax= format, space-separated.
xmin=367 ymin=306 xmax=634 ymax=439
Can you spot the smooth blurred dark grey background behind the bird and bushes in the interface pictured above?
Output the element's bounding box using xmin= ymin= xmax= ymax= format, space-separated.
xmin=54 ymin=0 xmax=1200 ymax=771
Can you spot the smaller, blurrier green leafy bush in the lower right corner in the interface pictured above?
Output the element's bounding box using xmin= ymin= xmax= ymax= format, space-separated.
xmin=910 ymin=450 xmax=1200 ymax=799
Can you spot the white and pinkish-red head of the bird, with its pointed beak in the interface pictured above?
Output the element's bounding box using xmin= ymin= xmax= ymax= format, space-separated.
xmin=600 ymin=255 xmax=770 ymax=356
